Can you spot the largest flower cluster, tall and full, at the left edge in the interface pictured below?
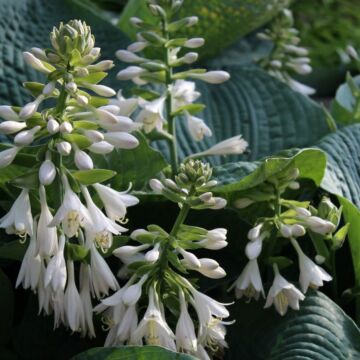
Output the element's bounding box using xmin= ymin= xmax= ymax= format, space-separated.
xmin=0 ymin=20 xmax=138 ymax=336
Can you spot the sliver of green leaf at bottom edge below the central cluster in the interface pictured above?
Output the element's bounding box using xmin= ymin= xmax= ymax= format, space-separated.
xmin=72 ymin=346 xmax=195 ymax=360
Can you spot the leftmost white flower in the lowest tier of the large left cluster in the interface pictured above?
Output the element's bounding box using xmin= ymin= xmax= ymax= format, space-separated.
xmin=15 ymin=224 xmax=41 ymax=291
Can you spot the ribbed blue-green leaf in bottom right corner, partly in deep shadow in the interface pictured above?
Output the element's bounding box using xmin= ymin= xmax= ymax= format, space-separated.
xmin=227 ymin=290 xmax=360 ymax=360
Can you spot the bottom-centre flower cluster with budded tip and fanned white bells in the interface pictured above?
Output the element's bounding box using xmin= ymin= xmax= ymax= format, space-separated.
xmin=95 ymin=160 xmax=229 ymax=359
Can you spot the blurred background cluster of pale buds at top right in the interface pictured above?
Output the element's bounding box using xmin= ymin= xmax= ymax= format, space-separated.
xmin=258 ymin=9 xmax=315 ymax=95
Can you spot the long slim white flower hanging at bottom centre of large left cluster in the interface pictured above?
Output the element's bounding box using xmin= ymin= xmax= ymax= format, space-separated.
xmin=64 ymin=261 xmax=85 ymax=331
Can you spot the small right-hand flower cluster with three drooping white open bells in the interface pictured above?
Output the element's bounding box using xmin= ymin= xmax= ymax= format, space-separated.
xmin=232 ymin=168 xmax=346 ymax=315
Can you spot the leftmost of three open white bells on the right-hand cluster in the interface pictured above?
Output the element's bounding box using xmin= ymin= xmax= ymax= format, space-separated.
xmin=231 ymin=259 xmax=265 ymax=300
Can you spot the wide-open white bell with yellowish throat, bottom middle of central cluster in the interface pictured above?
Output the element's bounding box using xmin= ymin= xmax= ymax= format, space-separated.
xmin=133 ymin=287 xmax=176 ymax=351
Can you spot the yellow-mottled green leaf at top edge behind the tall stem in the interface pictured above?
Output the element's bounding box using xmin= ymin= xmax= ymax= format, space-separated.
xmin=119 ymin=0 xmax=287 ymax=57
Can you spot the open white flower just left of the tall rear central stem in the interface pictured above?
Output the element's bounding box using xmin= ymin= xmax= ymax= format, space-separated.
xmin=136 ymin=96 xmax=165 ymax=133
